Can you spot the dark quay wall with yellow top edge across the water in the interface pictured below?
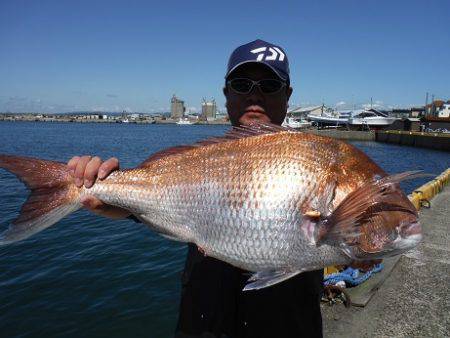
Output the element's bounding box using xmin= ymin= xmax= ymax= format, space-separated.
xmin=375 ymin=130 xmax=450 ymax=151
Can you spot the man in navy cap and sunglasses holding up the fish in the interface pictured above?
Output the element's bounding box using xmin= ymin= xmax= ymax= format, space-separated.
xmin=68 ymin=40 xmax=323 ymax=337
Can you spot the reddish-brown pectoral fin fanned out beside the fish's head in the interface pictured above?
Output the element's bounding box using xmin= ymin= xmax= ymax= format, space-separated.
xmin=309 ymin=171 xmax=425 ymax=247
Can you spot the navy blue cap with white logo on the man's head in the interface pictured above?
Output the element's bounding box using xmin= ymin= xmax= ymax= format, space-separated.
xmin=225 ymin=40 xmax=289 ymax=82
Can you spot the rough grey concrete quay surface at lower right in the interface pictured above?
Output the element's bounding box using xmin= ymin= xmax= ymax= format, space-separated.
xmin=322 ymin=186 xmax=450 ymax=337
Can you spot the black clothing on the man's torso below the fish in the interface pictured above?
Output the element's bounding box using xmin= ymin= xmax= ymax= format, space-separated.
xmin=175 ymin=244 xmax=323 ymax=338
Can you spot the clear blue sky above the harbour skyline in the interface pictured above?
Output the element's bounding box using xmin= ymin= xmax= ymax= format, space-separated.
xmin=0 ymin=0 xmax=450 ymax=113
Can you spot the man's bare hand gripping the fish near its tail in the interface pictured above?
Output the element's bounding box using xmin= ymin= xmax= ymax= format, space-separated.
xmin=67 ymin=156 xmax=131 ymax=219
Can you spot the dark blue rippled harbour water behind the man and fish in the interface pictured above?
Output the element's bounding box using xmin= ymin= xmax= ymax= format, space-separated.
xmin=0 ymin=122 xmax=450 ymax=337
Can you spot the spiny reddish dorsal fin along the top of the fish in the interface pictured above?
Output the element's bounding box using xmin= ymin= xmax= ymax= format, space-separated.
xmin=139 ymin=122 xmax=297 ymax=168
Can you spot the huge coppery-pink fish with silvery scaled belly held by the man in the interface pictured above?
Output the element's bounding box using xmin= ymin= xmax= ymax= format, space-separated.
xmin=0 ymin=123 xmax=422 ymax=290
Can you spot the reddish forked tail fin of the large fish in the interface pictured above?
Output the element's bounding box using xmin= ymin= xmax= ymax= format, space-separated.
xmin=0 ymin=155 xmax=81 ymax=245
